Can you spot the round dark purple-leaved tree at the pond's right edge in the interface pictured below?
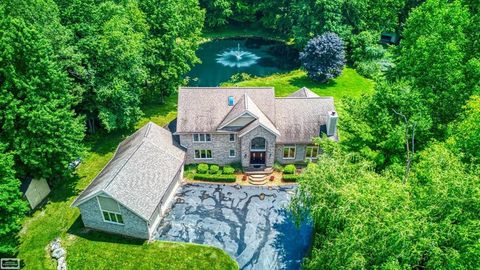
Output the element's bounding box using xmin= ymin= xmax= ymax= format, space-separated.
xmin=300 ymin=33 xmax=345 ymax=82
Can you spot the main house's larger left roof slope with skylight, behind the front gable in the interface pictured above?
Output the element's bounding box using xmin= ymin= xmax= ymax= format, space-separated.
xmin=177 ymin=87 xmax=275 ymax=133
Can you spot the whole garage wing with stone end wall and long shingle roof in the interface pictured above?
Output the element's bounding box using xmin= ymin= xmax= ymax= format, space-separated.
xmin=72 ymin=122 xmax=185 ymax=239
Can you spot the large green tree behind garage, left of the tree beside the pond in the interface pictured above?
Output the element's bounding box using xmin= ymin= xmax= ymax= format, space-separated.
xmin=57 ymin=0 xmax=148 ymax=131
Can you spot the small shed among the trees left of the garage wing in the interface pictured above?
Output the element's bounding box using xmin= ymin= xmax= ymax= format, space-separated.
xmin=20 ymin=177 xmax=50 ymax=209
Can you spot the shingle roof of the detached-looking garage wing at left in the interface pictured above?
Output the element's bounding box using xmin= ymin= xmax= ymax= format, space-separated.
xmin=72 ymin=122 xmax=185 ymax=220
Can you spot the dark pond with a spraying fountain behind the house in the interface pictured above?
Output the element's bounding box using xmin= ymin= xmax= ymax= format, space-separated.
xmin=187 ymin=38 xmax=300 ymax=86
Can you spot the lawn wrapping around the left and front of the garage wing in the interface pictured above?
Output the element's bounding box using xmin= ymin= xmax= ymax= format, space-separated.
xmin=18 ymin=96 xmax=236 ymax=269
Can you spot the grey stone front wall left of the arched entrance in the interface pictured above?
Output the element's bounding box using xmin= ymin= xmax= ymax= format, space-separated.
xmin=180 ymin=133 xmax=241 ymax=165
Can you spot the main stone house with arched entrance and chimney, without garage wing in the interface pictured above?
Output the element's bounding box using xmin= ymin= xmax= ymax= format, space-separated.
xmin=174 ymin=87 xmax=338 ymax=168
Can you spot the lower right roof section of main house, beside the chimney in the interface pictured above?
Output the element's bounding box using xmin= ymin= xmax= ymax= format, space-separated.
xmin=275 ymin=97 xmax=335 ymax=144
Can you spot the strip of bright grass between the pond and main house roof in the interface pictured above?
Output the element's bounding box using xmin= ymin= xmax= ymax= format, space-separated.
xmin=223 ymin=68 xmax=375 ymax=102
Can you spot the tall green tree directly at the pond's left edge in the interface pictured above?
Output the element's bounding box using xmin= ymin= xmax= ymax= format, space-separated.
xmin=140 ymin=0 xmax=205 ymax=102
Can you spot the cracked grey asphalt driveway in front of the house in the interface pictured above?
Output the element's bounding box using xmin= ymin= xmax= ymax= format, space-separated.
xmin=156 ymin=184 xmax=312 ymax=270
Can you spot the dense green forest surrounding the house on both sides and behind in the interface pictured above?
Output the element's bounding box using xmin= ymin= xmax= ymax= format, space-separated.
xmin=0 ymin=0 xmax=480 ymax=269
